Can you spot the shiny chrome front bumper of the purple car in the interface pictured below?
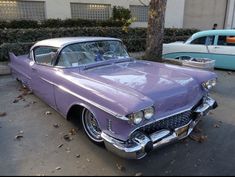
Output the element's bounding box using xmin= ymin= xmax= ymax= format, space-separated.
xmin=101 ymin=97 xmax=218 ymax=159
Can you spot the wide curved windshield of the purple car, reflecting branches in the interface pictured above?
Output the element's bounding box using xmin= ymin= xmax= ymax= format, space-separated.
xmin=57 ymin=41 xmax=129 ymax=67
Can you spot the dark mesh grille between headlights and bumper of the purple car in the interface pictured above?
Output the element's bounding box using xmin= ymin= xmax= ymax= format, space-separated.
xmin=141 ymin=111 xmax=195 ymax=134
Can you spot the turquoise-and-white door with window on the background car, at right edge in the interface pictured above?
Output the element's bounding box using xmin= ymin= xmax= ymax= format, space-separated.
xmin=209 ymin=35 xmax=235 ymax=69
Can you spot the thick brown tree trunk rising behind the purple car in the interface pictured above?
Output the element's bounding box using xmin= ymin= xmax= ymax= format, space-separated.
xmin=145 ymin=0 xmax=167 ymax=62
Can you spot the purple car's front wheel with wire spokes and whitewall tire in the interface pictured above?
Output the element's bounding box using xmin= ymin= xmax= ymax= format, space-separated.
xmin=82 ymin=109 xmax=103 ymax=144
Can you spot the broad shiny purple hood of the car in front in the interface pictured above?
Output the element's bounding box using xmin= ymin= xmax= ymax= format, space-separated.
xmin=68 ymin=61 xmax=213 ymax=118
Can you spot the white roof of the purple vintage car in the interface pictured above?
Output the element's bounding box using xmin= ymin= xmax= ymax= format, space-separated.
xmin=32 ymin=37 xmax=121 ymax=49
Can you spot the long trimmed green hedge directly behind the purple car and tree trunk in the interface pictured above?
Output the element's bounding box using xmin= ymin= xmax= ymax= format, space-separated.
xmin=0 ymin=27 xmax=197 ymax=61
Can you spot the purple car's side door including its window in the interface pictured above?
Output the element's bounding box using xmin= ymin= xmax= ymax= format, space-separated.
xmin=31 ymin=47 xmax=57 ymax=109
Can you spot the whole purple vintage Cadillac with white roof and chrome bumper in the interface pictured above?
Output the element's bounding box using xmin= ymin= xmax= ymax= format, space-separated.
xmin=10 ymin=37 xmax=217 ymax=159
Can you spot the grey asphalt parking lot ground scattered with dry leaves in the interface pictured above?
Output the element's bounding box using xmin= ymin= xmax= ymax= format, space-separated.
xmin=0 ymin=71 xmax=235 ymax=176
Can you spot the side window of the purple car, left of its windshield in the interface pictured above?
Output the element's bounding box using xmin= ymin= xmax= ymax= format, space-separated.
xmin=34 ymin=47 xmax=58 ymax=66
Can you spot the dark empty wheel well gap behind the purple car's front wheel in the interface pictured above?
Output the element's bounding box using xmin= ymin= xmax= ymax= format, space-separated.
xmin=67 ymin=105 xmax=85 ymax=122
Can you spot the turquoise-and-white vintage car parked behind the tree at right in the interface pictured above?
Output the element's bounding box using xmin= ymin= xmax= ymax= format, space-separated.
xmin=163 ymin=30 xmax=235 ymax=70
